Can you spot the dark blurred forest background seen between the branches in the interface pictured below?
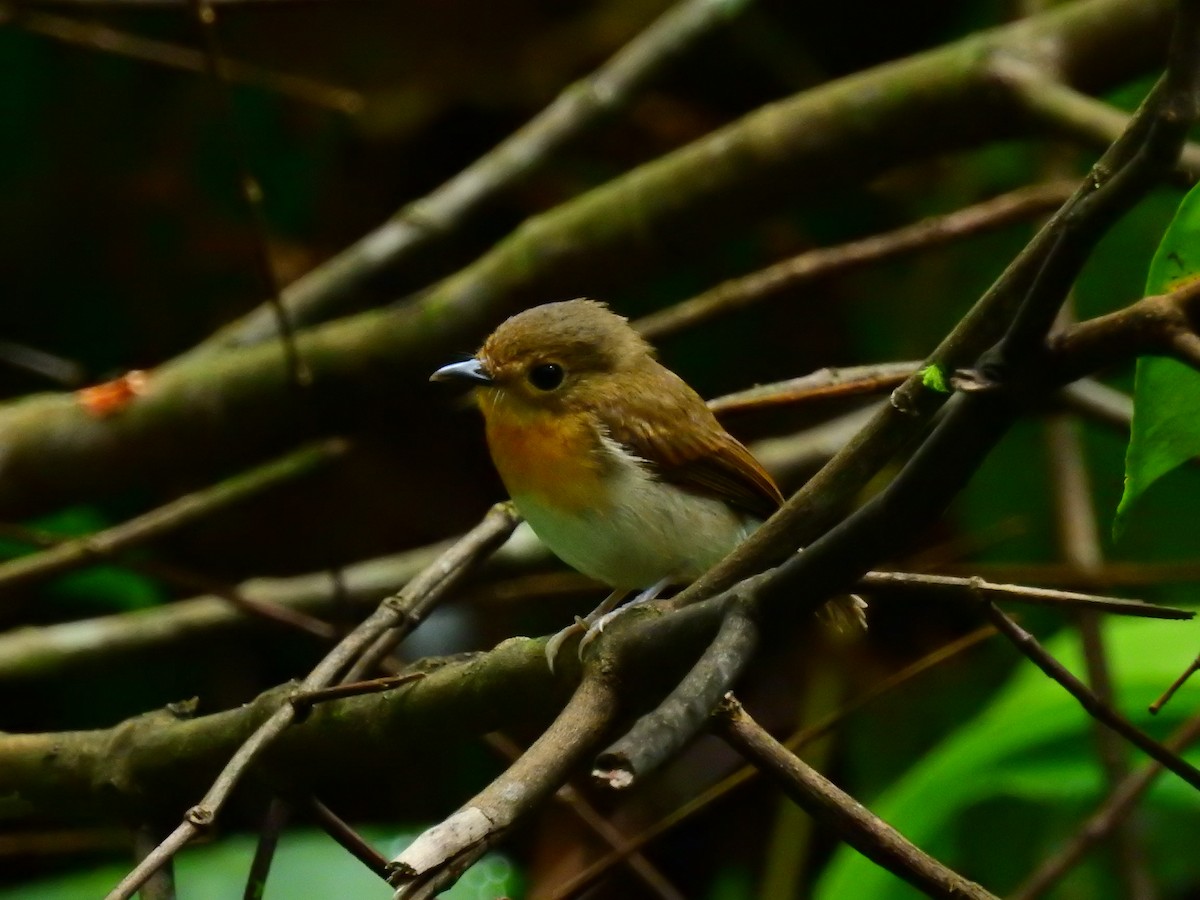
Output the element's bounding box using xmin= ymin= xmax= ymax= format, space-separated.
xmin=0 ymin=0 xmax=1200 ymax=898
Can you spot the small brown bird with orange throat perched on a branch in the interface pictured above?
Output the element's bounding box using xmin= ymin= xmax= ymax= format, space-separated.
xmin=430 ymin=299 xmax=864 ymax=667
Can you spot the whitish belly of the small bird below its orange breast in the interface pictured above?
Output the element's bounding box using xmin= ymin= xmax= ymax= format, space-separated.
xmin=512 ymin=444 xmax=758 ymax=589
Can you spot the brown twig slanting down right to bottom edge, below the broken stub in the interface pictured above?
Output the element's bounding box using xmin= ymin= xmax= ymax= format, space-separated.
xmin=713 ymin=694 xmax=995 ymax=900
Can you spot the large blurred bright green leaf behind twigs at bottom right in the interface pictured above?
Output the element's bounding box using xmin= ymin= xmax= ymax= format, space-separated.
xmin=814 ymin=620 xmax=1200 ymax=900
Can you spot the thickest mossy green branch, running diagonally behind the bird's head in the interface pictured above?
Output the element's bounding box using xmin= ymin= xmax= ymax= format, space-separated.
xmin=0 ymin=0 xmax=1170 ymax=515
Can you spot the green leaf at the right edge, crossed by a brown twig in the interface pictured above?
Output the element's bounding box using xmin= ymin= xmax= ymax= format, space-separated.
xmin=1112 ymin=185 xmax=1200 ymax=538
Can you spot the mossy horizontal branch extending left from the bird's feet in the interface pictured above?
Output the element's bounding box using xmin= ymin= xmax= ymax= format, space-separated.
xmin=0 ymin=638 xmax=563 ymax=822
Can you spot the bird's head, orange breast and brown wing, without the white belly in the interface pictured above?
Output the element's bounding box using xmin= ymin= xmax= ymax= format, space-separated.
xmin=448 ymin=300 xmax=782 ymax=518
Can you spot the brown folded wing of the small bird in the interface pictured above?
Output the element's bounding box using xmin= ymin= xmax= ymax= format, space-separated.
xmin=604 ymin=370 xmax=784 ymax=518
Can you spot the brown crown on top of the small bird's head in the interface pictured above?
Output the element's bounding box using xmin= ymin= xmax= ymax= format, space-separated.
xmin=479 ymin=299 xmax=654 ymax=391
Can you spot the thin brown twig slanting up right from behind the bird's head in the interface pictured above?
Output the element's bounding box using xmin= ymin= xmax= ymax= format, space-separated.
xmin=634 ymin=181 xmax=1074 ymax=340
